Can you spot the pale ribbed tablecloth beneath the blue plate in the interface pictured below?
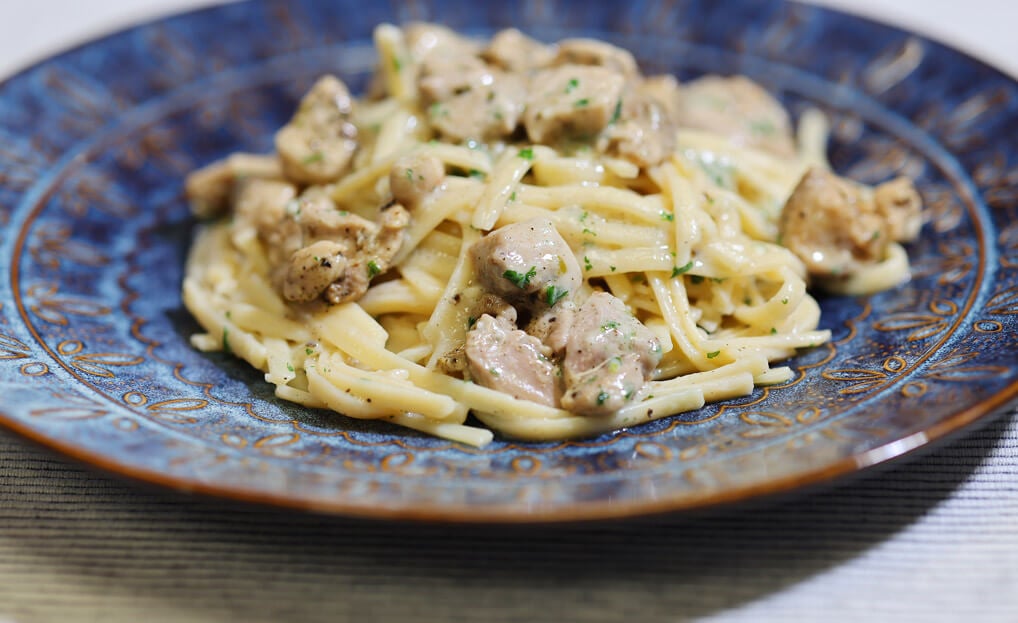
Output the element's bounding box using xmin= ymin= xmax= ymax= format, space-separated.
xmin=0 ymin=0 xmax=1018 ymax=623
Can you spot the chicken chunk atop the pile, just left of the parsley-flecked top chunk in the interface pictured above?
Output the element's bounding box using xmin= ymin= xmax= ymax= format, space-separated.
xmin=418 ymin=54 xmax=526 ymax=141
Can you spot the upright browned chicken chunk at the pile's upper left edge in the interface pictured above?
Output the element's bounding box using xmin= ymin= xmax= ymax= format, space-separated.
xmin=276 ymin=75 xmax=357 ymax=184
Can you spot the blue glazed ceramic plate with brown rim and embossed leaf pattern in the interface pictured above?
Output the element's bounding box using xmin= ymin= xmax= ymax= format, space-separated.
xmin=0 ymin=0 xmax=1018 ymax=521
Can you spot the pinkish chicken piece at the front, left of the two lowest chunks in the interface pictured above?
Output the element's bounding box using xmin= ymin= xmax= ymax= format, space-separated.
xmin=465 ymin=314 xmax=558 ymax=406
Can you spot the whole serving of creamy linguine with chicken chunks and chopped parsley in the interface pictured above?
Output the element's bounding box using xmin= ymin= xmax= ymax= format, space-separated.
xmin=183 ymin=23 xmax=921 ymax=446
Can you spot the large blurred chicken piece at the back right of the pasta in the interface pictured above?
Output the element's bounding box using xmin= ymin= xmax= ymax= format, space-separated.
xmin=678 ymin=75 xmax=796 ymax=158
